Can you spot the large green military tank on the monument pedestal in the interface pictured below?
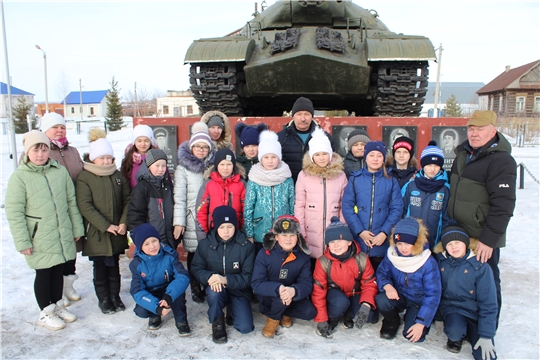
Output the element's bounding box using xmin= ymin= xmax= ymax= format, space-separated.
xmin=184 ymin=0 xmax=435 ymax=117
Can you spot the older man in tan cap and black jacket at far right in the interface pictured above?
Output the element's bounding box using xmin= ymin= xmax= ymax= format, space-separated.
xmin=448 ymin=110 xmax=516 ymax=322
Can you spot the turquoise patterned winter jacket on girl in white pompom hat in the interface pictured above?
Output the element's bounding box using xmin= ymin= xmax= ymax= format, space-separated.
xmin=244 ymin=162 xmax=294 ymax=243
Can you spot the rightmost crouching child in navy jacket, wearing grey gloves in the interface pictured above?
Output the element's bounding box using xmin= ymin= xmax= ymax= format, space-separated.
xmin=435 ymin=226 xmax=498 ymax=360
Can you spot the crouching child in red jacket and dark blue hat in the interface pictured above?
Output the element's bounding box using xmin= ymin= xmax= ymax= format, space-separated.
xmin=311 ymin=216 xmax=378 ymax=338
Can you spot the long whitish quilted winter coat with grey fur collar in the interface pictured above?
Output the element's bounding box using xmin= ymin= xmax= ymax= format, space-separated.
xmin=173 ymin=141 xmax=215 ymax=253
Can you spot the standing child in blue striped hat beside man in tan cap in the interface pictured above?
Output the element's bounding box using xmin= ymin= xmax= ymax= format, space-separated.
xmin=401 ymin=141 xmax=454 ymax=251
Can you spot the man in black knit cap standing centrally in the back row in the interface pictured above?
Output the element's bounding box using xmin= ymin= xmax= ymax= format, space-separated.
xmin=277 ymin=97 xmax=335 ymax=184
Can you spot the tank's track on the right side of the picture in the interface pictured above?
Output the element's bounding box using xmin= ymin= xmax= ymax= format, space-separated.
xmin=373 ymin=61 xmax=429 ymax=117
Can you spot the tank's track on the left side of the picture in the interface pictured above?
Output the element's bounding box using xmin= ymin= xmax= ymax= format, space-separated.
xmin=189 ymin=63 xmax=243 ymax=116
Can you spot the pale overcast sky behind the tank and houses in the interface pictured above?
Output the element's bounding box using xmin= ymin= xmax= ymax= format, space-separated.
xmin=0 ymin=0 xmax=540 ymax=102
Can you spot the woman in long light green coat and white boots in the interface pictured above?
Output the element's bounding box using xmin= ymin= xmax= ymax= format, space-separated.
xmin=5 ymin=130 xmax=84 ymax=330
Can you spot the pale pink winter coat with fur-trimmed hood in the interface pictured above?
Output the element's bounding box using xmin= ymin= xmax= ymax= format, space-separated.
xmin=294 ymin=153 xmax=347 ymax=259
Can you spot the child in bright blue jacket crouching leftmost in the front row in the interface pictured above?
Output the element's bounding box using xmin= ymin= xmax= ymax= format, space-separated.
xmin=129 ymin=223 xmax=191 ymax=336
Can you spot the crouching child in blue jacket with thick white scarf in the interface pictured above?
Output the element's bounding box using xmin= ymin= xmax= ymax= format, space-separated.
xmin=375 ymin=218 xmax=441 ymax=342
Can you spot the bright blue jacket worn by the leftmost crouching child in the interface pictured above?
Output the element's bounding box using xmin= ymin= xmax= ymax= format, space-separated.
xmin=129 ymin=243 xmax=189 ymax=314
